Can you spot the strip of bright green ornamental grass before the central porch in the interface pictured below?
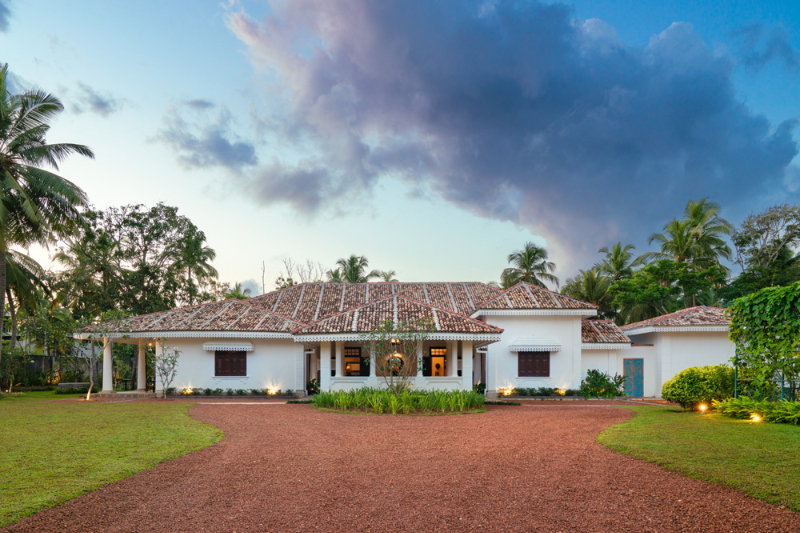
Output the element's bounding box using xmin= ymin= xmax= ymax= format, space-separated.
xmin=313 ymin=388 xmax=486 ymax=415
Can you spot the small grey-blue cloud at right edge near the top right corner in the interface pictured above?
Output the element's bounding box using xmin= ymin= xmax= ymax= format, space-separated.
xmin=733 ymin=24 xmax=800 ymax=70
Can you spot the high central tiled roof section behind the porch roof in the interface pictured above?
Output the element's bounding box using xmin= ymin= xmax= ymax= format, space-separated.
xmin=247 ymin=282 xmax=500 ymax=324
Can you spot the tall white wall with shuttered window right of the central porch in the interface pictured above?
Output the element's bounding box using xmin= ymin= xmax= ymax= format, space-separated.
xmin=482 ymin=315 xmax=582 ymax=393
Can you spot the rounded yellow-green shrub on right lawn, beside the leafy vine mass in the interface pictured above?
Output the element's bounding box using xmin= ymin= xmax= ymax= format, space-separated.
xmin=661 ymin=365 xmax=734 ymax=409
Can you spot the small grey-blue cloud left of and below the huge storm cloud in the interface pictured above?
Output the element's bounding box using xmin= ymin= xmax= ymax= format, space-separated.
xmin=157 ymin=101 xmax=258 ymax=172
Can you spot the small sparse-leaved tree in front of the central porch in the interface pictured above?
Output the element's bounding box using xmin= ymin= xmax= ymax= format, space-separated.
xmin=361 ymin=318 xmax=434 ymax=394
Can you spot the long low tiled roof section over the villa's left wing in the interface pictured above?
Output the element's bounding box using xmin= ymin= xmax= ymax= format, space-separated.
xmin=81 ymin=300 xmax=303 ymax=334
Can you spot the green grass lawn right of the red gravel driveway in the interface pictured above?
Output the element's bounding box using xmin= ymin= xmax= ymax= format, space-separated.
xmin=598 ymin=407 xmax=800 ymax=511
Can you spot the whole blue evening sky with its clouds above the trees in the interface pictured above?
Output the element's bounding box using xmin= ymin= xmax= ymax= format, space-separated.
xmin=0 ymin=0 xmax=800 ymax=292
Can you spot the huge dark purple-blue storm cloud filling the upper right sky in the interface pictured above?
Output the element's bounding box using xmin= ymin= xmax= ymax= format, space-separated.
xmin=229 ymin=0 xmax=797 ymax=264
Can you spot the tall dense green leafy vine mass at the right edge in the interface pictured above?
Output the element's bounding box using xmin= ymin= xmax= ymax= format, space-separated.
xmin=728 ymin=282 xmax=800 ymax=393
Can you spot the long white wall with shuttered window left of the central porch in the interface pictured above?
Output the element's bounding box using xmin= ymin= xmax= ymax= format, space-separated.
xmin=158 ymin=338 xmax=305 ymax=391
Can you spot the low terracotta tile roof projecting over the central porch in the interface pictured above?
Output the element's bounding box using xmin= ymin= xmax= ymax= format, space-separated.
xmin=294 ymin=294 xmax=503 ymax=335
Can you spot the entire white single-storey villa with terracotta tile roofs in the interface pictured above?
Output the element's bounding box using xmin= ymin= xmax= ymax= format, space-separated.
xmin=76 ymin=282 xmax=733 ymax=396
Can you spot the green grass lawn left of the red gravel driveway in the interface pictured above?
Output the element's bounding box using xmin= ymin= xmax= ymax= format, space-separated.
xmin=0 ymin=400 xmax=222 ymax=527
